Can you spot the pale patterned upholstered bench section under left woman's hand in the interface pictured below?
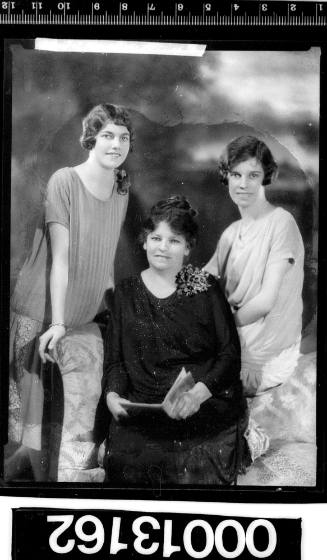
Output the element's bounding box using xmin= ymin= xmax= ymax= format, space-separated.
xmin=57 ymin=323 xmax=104 ymax=482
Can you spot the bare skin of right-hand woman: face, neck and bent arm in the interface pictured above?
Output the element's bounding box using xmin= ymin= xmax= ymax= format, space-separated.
xmin=213 ymin=158 xmax=292 ymax=326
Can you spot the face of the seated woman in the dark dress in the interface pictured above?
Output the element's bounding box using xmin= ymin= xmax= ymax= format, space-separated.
xmin=143 ymin=222 xmax=190 ymax=274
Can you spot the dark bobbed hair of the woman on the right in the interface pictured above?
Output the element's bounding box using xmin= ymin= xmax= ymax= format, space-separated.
xmin=218 ymin=136 xmax=278 ymax=186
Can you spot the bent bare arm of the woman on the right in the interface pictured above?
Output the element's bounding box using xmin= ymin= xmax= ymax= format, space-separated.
xmin=234 ymin=259 xmax=292 ymax=327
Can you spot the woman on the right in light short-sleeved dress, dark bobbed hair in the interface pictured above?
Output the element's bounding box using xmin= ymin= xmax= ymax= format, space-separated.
xmin=205 ymin=136 xmax=304 ymax=456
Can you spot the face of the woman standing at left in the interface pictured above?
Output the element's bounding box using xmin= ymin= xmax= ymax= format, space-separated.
xmin=93 ymin=121 xmax=130 ymax=169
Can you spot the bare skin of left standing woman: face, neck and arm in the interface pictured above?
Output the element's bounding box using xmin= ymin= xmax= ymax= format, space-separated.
xmin=39 ymin=121 xmax=130 ymax=363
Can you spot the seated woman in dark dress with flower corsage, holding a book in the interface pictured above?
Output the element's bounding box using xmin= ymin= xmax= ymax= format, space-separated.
xmin=104 ymin=196 xmax=247 ymax=486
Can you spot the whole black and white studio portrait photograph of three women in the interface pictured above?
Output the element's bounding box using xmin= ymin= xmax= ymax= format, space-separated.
xmin=4 ymin=40 xmax=320 ymax=492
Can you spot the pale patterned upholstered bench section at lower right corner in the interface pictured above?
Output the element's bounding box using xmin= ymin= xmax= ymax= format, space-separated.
xmin=238 ymin=352 xmax=317 ymax=487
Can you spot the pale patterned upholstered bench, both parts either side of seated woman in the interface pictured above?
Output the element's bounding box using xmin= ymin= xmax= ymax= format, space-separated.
xmin=57 ymin=323 xmax=316 ymax=486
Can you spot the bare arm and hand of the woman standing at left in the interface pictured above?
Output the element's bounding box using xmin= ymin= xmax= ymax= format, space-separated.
xmin=39 ymin=222 xmax=69 ymax=363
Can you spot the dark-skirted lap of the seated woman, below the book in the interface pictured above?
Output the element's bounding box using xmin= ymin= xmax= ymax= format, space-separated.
xmin=104 ymin=412 xmax=247 ymax=487
